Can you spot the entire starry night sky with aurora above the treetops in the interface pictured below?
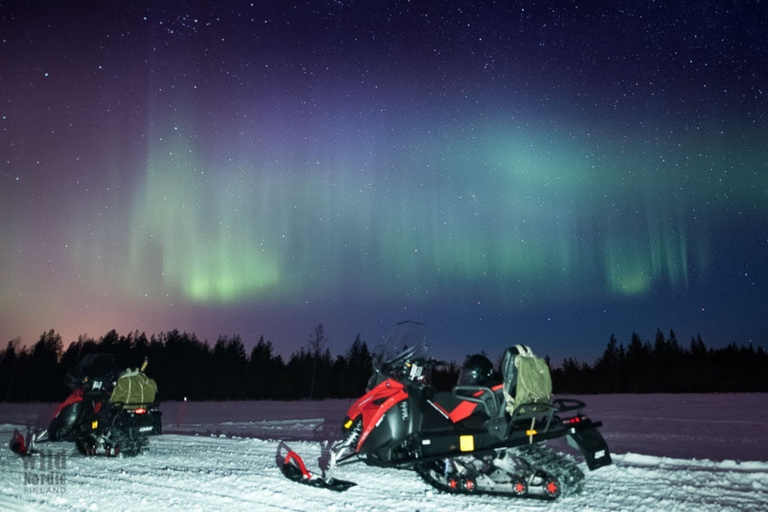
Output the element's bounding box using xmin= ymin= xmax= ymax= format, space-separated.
xmin=0 ymin=0 xmax=768 ymax=363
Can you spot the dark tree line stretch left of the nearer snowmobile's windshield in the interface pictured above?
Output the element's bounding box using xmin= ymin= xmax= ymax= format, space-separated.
xmin=0 ymin=324 xmax=372 ymax=402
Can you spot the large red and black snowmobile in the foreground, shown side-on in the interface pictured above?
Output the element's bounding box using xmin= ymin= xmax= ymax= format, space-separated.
xmin=278 ymin=322 xmax=612 ymax=500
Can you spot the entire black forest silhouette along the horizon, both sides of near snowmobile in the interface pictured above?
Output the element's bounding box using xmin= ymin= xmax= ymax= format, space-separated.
xmin=0 ymin=324 xmax=768 ymax=402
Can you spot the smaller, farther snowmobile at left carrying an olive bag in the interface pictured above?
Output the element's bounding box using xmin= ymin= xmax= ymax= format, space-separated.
xmin=10 ymin=353 xmax=162 ymax=457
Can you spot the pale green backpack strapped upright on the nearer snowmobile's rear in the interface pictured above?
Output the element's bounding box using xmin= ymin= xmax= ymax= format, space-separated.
xmin=501 ymin=345 xmax=552 ymax=414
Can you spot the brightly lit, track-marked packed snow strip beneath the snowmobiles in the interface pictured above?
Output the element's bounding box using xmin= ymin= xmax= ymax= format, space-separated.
xmin=0 ymin=429 xmax=768 ymax=512
